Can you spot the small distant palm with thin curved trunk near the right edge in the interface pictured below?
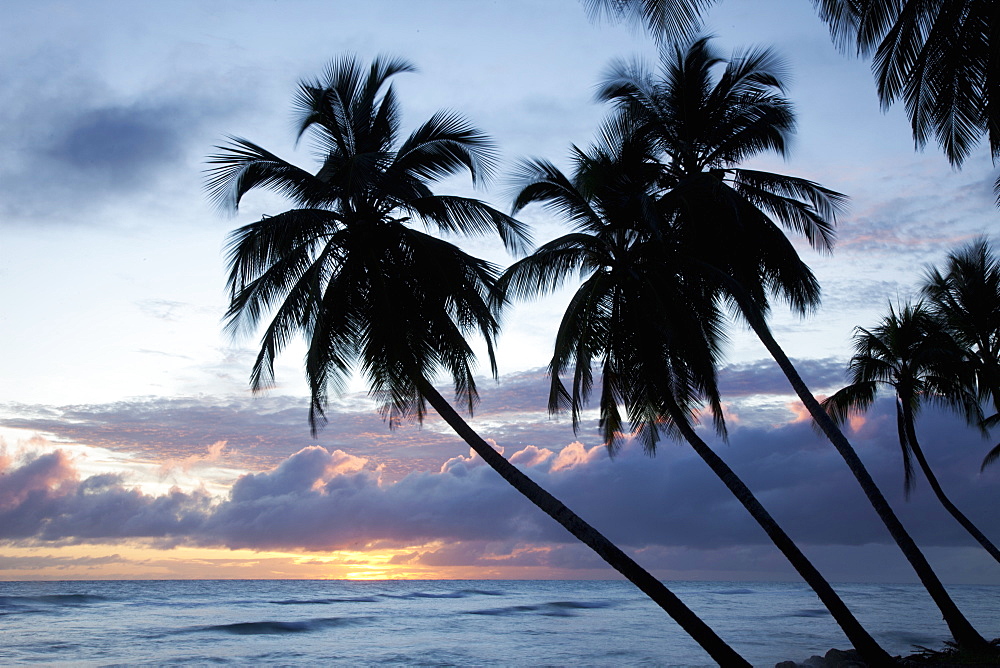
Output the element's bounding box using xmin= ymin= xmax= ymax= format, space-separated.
xmin=823 ymin=303 xmax=1000 ymax=562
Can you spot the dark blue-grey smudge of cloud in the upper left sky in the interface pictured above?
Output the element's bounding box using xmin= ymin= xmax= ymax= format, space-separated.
xmin=0 ymin=43 xmax=255 ymax=227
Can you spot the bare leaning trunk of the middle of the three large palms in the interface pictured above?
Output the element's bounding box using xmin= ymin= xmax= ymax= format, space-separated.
xmin=668 ymin=405 xmax=896 ymax=666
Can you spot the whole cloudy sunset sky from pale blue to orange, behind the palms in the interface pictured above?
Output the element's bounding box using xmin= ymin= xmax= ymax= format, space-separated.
xmin=0 ymin=0 xmax=1000 ymax=584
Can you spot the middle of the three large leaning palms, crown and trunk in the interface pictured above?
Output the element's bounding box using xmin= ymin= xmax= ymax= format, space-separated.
xmin=500 ymin=115 xmax=894 ymax=665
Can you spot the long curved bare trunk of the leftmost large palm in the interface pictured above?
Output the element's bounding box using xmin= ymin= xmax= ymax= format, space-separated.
xmin=420 ymin=382 xmax=750 ymax=668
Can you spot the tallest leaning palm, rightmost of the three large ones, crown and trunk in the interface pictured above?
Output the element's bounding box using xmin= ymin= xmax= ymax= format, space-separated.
xmin=599 ymin=38 xmax=986 ymax=647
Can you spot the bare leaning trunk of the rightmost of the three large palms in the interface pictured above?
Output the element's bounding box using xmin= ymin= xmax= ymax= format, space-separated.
xmin=736 ymin=308 xmax=990 ymax=650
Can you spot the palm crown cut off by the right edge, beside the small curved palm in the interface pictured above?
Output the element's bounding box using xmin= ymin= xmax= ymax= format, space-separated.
xmin=923 ymin=239 xmax=1000 ymax=468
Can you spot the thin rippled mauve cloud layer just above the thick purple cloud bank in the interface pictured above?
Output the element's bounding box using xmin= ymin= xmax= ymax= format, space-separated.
xmin=0 ymin=359 xmax=845 ymax=472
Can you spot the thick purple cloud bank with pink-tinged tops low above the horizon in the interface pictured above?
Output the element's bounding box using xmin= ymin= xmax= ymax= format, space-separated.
xmin=0 ymin=394 xmax=1000 ymax=570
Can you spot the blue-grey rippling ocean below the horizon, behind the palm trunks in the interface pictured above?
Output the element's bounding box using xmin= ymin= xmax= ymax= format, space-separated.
xmin=0 ymin=580 xmax=1000 ymax=666
